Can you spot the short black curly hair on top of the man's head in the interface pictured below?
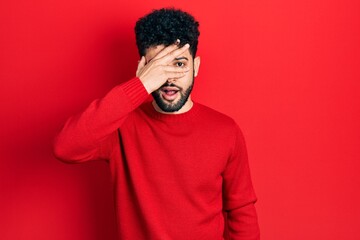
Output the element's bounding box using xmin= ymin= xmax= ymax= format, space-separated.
xmin=135 ymin=8 xmax=200 ymax=58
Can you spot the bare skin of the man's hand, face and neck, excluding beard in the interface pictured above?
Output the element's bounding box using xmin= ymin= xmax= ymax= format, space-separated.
xmin=136 ymin=44 xmax=200 ymax=114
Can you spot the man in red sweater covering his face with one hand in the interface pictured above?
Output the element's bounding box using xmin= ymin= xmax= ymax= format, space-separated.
xmin=54 ymin=9 xmax=259 ymax=240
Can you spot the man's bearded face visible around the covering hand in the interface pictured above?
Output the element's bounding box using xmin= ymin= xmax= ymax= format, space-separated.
xmin=145 ymin=45 xmax=200 ymax=113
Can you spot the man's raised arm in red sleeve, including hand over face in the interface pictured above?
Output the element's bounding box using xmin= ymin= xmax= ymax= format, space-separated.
xmin=54 ymin=41 xmax=189 ymax=162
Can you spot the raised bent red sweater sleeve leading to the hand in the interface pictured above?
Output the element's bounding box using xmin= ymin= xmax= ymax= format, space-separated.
xmin=54 ymin=77 xmax=148 ymax=163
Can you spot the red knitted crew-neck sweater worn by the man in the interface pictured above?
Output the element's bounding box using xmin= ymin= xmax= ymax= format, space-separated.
xmin=54 ymin=78 xmax=259 ymax=240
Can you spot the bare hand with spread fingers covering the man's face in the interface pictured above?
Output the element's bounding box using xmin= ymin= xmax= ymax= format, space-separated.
xmin=136 ymin=41 xmax=190 ymax=94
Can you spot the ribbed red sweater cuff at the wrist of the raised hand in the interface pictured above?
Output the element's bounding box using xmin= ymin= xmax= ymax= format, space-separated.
xmin=122 ymin=77 xmax=149 ymax=109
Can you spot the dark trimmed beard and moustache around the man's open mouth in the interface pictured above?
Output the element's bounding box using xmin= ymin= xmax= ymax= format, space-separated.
xmin=151 ymin=78 xmax=194 ymax=112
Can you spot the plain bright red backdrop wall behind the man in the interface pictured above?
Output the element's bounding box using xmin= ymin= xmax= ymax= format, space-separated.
xmin=0 ymin=0 xmax=360 ymax=240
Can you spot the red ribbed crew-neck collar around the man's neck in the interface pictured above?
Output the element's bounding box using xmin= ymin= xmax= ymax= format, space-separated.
xmin=141 ymin=101 xmax=200 ymax=122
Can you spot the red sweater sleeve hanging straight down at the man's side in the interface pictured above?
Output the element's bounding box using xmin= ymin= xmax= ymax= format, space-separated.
xmin=223 ymin=125 xmax=260 ymax=240
